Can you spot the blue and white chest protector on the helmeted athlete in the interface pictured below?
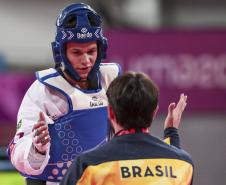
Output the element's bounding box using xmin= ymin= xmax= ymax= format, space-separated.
xmin=23 ymin=69 xmax=113 ymax=182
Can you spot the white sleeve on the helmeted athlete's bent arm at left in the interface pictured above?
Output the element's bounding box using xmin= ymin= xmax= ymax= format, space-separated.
xmin=10 ymin=81 xmax=53 ymax=175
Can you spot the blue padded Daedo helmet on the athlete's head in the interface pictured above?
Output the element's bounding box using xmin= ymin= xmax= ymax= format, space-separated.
xmin=52 ymin=3 xmax=108 ymax=81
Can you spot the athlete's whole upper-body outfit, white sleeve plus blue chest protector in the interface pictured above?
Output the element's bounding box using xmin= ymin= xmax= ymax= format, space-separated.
xmin=9 ymin=63 xmax=121 ymax=184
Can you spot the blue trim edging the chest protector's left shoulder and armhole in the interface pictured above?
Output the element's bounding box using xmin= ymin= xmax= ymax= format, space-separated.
xmin=35 ymin=72 xmax=73 ymax=114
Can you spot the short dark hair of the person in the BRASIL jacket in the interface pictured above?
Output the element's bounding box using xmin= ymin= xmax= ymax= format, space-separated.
xmin=107 ymin=72 xmax=159 ymax=129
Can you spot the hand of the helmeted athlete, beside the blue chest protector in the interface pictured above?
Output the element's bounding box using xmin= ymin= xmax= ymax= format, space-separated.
xmin=32 ymin=112 xmax=50 ymax=155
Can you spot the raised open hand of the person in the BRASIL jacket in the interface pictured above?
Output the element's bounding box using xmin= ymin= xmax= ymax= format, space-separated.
xmin=164 ymin=93 xmax=187 ymax=129
